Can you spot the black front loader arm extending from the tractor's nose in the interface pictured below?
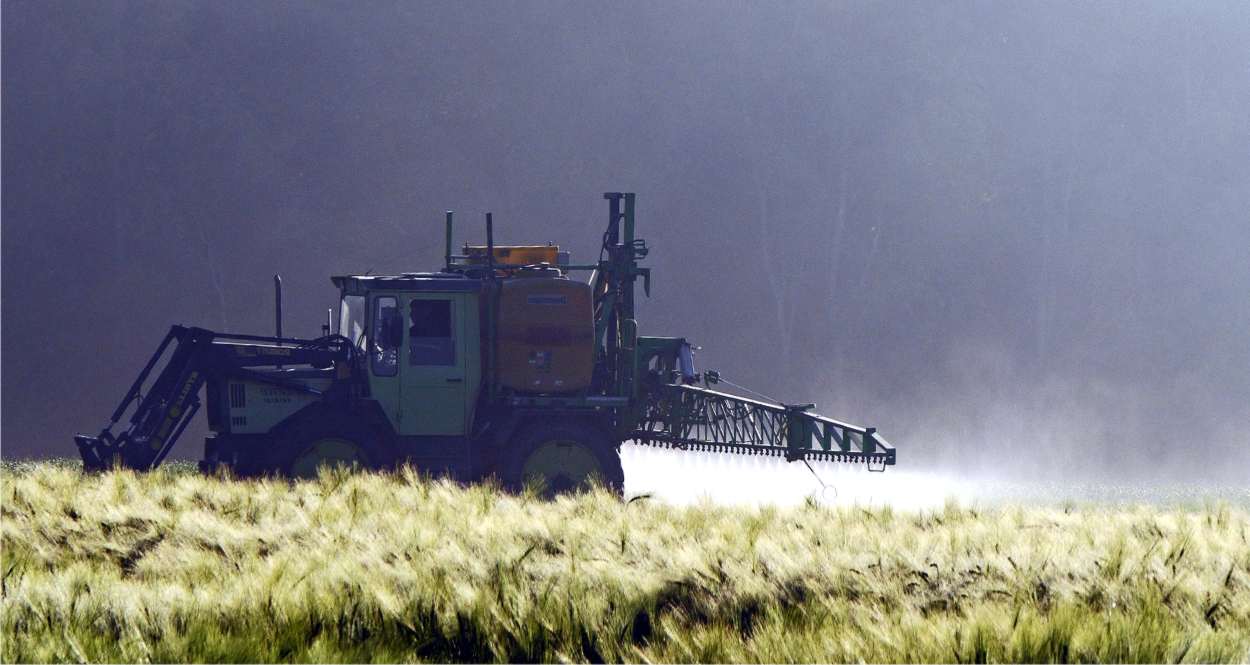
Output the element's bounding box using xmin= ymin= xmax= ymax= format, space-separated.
xmin=74 ymin=325 xmax=354 ymax=471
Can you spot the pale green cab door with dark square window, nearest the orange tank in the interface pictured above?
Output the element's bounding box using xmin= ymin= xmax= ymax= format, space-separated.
xmin=399 ymin=293 xmax=469 ymax=436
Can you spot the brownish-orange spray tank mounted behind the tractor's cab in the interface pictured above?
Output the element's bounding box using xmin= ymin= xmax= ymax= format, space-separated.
xmin=495 ymin=271 xmax=595 ymax=393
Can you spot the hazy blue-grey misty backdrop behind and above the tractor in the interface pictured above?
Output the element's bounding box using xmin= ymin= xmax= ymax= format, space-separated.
xmin=0 ymin=1 xmax=1250 ymax=483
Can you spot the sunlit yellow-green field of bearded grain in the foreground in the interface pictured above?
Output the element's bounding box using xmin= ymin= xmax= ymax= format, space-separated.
xmin=0 ymin=464 xmax=1250 ymax=663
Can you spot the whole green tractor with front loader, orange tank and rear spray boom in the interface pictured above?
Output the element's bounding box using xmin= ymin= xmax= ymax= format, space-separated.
xmin=74 ymin=193 xmax=895 ymax=491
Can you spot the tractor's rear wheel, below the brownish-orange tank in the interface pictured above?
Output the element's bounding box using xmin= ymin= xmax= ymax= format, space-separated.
xmin=504 ymin=423 xmax=625 ymax=496
